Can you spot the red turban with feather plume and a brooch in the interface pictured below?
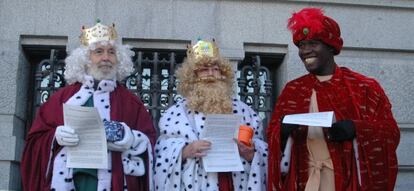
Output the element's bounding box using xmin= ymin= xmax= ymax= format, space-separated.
xmin=288 ymin=8 xmax=343 ymax=55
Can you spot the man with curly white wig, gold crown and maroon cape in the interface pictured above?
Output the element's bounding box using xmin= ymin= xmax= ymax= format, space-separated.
xmin=21 ymin=23 xmax=156 ymax=191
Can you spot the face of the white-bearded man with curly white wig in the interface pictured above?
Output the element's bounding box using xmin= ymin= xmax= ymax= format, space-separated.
xmin=88 ymin=44 xmax=118 ymax=80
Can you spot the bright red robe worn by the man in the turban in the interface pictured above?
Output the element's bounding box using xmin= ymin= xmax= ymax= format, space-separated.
xmin=266 ymin=67 xmax=400 ymax=191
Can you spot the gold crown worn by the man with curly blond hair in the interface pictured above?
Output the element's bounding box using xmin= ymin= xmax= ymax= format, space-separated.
xmin=187 ymin=39 xmax=219 ymax=60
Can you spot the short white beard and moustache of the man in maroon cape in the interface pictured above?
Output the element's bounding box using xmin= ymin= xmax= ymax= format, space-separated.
xmin=87 ymin=62 xmax=118 ymax=80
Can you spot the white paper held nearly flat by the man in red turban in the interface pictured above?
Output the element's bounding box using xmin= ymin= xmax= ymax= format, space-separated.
xmin=283 ymin=111 xmax=335 ymax=127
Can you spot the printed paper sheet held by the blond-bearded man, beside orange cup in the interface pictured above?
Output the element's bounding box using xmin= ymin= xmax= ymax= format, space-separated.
xmin=200 ymin=114 xmax=243 ymax=172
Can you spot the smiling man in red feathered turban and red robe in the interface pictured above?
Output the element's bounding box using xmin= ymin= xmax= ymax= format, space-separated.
xmin=267 ymin=8 xmax=400 ymax=191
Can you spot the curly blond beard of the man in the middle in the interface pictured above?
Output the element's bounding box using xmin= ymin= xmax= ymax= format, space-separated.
xmin=187 ymin=78 xmax=233 ymax=114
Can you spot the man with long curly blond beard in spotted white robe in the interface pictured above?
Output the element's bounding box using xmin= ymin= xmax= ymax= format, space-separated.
xmin=154 ymin=41 xmax=267 ymax=191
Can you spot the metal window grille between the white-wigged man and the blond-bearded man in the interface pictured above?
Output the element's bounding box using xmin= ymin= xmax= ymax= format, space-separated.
xmin=125 ymin=50 xmax=185 ymax=127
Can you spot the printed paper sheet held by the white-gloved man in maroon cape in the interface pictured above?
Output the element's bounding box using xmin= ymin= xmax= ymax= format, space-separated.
xmin=63 ymin=104 xmax=108 ymax=169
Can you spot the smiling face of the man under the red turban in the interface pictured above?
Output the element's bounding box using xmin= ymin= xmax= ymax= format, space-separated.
xmin=298 ymin=40 xmax=335 ymax=76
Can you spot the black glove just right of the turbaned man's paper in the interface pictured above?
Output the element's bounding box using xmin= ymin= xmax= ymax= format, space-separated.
xmin=328 ymin=120 xmax=355 ymax=141
